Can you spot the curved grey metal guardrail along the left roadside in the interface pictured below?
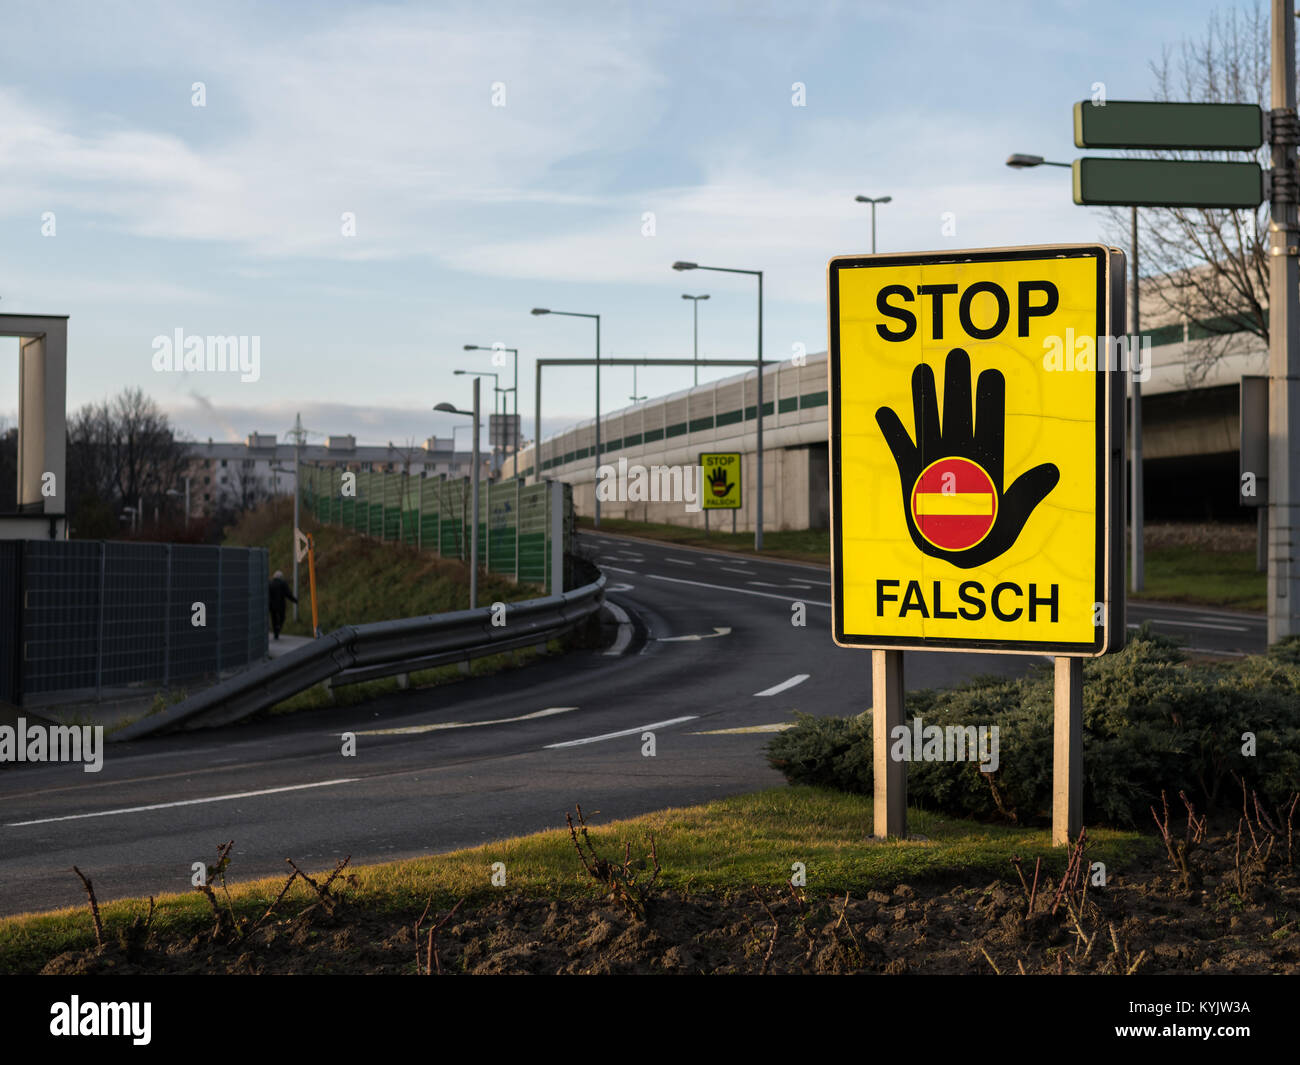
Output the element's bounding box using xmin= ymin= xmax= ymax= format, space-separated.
xmin=109 ymin=575 xmax=605 ymax=743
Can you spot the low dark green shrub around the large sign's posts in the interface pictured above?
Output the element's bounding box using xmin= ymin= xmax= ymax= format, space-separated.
xmin=767 ymin=627 xmax=1300 ymax=826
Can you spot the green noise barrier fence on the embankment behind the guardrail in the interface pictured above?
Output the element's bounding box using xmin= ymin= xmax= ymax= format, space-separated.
xmin=300 ymin=463 xmax=573 ymax=588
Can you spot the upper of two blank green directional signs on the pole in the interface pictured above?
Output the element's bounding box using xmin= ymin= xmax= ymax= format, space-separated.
xmin=1074 ymin=100 xmax=1264 ymax=152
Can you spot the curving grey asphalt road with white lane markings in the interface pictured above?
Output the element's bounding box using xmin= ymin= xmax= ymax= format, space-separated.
xmin=0 ymin=533 xmax=1264 ymax=914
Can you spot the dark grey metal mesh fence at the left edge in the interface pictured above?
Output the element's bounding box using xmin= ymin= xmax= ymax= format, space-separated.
xmin=0 ymin=540 xmax=267 ymax=705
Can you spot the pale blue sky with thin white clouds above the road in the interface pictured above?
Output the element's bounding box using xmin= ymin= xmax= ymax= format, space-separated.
xmin=0 ymin=0 xmax=1225 ymax=443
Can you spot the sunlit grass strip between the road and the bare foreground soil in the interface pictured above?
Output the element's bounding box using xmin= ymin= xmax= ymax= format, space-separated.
xmin=0 ymin=787 xmax=1153 ymax=973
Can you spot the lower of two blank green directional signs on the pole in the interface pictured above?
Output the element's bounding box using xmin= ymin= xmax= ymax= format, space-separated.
xmin=1074 ymin=157 xmax=1264 ymax=207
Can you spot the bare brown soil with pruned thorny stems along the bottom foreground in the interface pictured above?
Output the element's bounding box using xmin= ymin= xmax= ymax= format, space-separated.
xmin=42 ymin=824 xmax=1300 ymax=974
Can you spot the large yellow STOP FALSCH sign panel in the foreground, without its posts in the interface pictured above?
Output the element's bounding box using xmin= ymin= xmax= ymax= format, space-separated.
xmin=832 ymin=244 xmax=1136 ymax=655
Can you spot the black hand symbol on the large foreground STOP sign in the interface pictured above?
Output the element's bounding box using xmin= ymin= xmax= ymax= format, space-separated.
xmin=876 ymin=347 xmax=1061 ymax=570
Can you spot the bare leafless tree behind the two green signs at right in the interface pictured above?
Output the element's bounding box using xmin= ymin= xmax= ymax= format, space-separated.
xmin=1106 ymin=3 xmax=1270 ymax=384
